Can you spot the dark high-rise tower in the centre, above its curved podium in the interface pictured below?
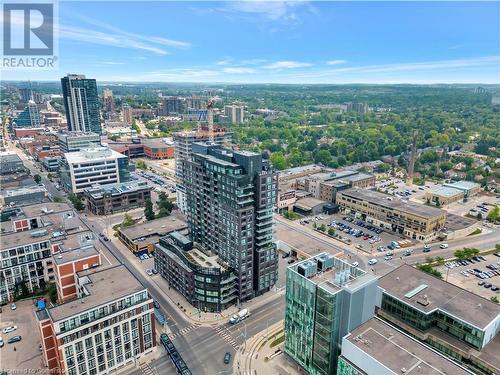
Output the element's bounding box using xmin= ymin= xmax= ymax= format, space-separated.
xmin=182 ymin=142 xmax=278 ymax=301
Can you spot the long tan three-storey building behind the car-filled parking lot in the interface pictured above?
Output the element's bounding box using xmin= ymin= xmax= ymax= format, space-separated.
xmin=336 ymin=189 xmax=446 ymax=241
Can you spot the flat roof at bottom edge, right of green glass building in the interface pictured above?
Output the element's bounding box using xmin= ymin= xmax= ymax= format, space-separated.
xmin=344 ymin=318 xmax=471 ymax=375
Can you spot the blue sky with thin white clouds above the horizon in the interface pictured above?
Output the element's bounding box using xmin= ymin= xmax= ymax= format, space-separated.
xmin=3 ymin=1 xmax=500 ymax=83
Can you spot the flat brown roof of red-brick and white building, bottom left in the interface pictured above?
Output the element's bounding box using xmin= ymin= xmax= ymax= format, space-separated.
xmin=48 ymin=265 xmax=145 ymax=322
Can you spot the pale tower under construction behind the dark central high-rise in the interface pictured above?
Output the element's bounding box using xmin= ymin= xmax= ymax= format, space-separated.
xmin=173 ymin=127 xmax=231 ymax=214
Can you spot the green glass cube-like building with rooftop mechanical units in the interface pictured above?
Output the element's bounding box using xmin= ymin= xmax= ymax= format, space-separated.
xmin=285 ymin=253 xmax=377 ymax=375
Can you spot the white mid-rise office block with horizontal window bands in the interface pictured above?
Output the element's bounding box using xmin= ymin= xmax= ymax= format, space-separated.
xmin=61 ymin=147 xmax=130 ymax=194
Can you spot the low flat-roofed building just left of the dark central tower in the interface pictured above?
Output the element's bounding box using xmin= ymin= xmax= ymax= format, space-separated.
xmin=118 ymin=213 xmax=187 ymax=254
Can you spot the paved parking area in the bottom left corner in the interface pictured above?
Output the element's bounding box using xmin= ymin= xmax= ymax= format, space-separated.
xmin=0 ymin=300 xmax=44 ymax=373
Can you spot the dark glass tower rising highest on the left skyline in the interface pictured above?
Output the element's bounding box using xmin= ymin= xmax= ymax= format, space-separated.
xmin=61 ymin=74 xmax=101 ymax=134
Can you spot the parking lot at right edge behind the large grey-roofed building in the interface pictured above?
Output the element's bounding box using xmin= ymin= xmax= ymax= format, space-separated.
xmin=437 ymin=253 xmax=500 ymax=299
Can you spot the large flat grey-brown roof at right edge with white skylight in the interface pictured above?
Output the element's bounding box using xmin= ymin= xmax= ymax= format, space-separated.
xmin=378 ymin=264 xmax=500 ymax=329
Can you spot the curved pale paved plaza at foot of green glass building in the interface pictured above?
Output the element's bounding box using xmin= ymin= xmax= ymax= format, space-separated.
xmin=233 ymin=320 xmax=303 ymax=375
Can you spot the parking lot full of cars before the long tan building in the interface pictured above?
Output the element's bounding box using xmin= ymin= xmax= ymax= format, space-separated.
xmin=300 ymin=214 xmax=409 ymax=254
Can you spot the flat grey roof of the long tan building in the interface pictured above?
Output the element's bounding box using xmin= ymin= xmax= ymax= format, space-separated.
xmin=338 ymin=189 xmax=446 ymax=218
